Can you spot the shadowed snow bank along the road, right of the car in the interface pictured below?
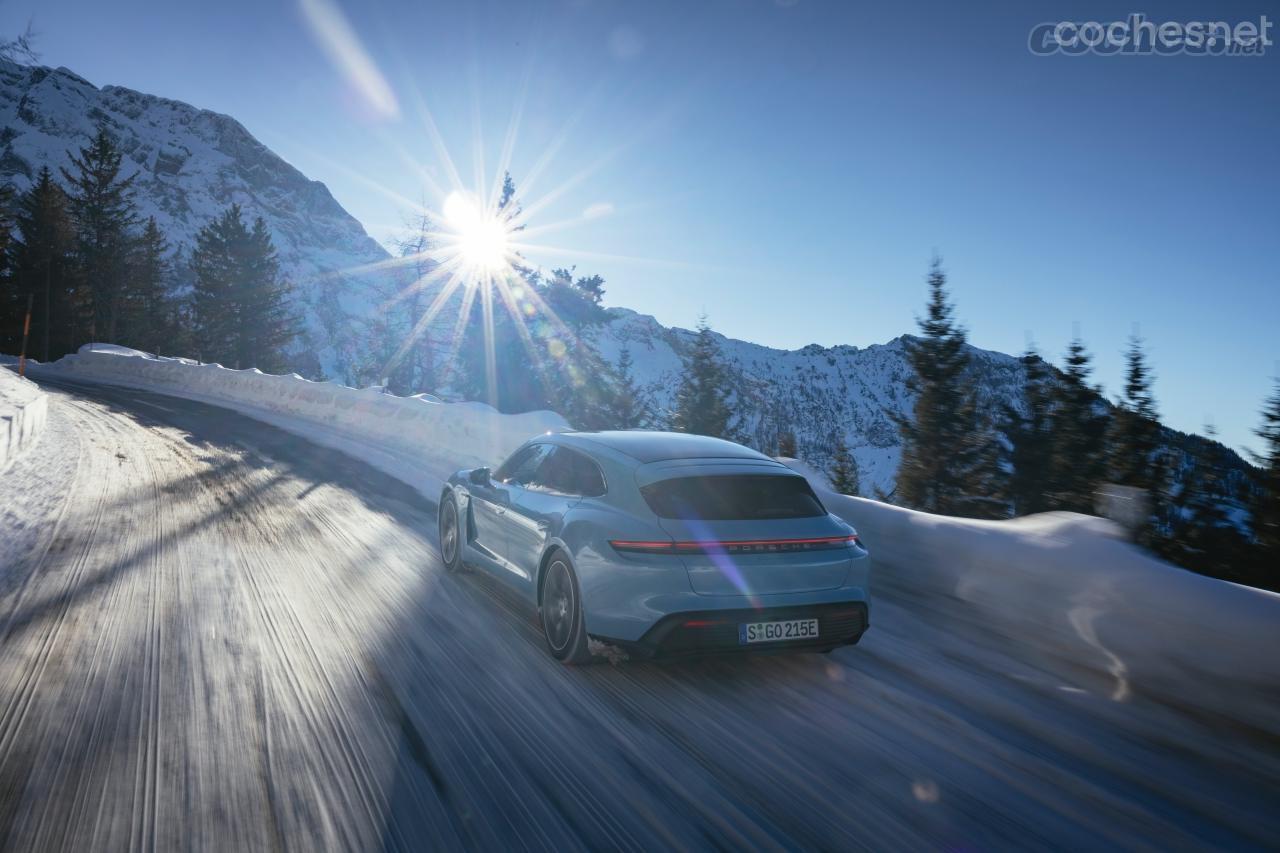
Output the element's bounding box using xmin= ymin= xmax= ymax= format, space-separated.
xmin=783 ymin=460 xmax=1280 ymax=734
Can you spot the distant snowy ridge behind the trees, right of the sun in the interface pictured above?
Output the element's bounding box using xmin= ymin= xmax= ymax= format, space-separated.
xmin=598 ymin=309 xmax=1023 ymax=494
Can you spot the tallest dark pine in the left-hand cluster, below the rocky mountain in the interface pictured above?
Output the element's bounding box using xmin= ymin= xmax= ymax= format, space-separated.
xmin=61 ymin=128 xmax=137 ymax=343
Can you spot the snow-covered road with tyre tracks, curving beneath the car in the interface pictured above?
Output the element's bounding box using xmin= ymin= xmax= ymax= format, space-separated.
xmin=0 ymin=383 xmax=1280 ymax=850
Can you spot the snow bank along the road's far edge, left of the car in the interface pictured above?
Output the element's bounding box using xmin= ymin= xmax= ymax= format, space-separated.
xmin=28 ymin=345 xmax=568 ymax=497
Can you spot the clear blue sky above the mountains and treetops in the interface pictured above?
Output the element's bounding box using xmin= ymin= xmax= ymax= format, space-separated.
xmin=0 ymin=0 xmax=1280 ymax=447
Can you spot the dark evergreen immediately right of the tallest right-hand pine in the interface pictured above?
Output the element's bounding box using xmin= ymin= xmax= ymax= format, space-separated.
xmin=1004 ymin=347 xmax=1053 ymax=515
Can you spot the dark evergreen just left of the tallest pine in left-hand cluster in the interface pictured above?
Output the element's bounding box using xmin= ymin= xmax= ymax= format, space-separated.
xmin=10 ymin=167 xmax=83 ymax=361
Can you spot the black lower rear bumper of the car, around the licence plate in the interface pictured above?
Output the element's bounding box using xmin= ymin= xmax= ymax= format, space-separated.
xmin=596 ymin=601 xmax=869 ymax=658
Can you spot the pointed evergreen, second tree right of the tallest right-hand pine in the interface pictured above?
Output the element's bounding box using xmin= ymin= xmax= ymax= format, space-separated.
xmin=1048 ymin=338 xmax=1107 ymax=514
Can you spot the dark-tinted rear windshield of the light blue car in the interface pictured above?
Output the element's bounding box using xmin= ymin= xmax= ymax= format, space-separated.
xmin=640 ymin=474 xmax=827 ymax=521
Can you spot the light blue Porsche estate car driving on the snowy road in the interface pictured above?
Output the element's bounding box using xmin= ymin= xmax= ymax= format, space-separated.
xmin=439 ymin=430 xmax=870 ymax=663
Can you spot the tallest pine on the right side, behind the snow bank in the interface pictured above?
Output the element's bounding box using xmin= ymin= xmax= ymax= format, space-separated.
xmin=895 ymin=259 xmax=1007 ymax=517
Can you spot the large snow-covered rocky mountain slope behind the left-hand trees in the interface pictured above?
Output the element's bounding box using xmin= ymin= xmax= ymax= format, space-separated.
xmin=0 ymin=60 xmax=388 ymax=377
